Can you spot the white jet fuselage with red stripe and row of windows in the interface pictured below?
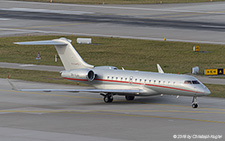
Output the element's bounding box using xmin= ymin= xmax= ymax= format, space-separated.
xmin=62 ymin=66 xmax=210 ymax=96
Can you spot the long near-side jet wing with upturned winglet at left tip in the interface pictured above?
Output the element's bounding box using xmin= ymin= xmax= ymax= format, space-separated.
xmin=8 ymin=79 xmax=140 ymax=94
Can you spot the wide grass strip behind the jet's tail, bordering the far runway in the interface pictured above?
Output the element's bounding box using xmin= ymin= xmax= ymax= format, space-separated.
xmin=0 ymin=36 xmax=225 ymax=73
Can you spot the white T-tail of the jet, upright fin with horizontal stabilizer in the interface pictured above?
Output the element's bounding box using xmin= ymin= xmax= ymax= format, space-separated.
xmin=15 ymin=38 xmax=94 ymax=70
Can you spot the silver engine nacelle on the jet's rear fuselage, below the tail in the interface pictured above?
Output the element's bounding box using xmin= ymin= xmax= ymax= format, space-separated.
xmin=61 ymin=69 xmax=95 ymax=81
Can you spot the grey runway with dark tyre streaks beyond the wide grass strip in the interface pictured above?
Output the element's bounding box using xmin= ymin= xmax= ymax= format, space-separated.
xmin=0 ymin=0 xmax=225 ymax=44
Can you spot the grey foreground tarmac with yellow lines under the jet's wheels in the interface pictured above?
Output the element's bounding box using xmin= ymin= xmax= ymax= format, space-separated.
xmin=0 ymin=79 xmax=225 ymax=141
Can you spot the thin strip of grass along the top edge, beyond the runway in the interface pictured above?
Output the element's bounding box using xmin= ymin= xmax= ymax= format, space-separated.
xmin=15 ymin=0 xmax=224 ymax=4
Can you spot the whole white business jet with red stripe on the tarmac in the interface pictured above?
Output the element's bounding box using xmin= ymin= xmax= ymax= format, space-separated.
xmin=9 ymin=38 xmax=211 ymax=108
